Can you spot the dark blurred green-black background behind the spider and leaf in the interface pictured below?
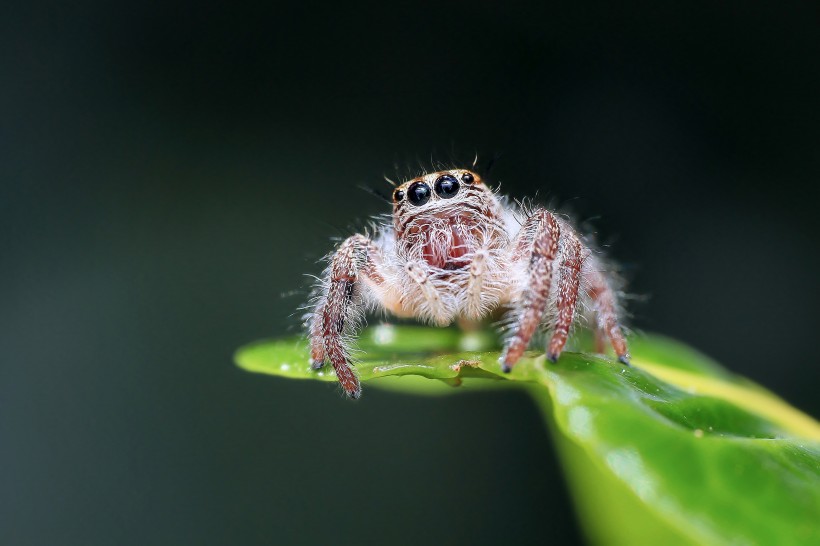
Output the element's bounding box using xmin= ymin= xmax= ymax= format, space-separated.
xmin=0 ymin=1 xmax=820 ymax=545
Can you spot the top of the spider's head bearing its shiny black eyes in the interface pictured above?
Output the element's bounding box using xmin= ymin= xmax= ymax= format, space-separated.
xmin=393 ymin=169 xmax=494 ymax=229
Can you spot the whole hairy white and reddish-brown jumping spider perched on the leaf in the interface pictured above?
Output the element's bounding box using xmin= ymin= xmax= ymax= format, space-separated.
xmin=307 ymin=169 xmax=629 ymax=398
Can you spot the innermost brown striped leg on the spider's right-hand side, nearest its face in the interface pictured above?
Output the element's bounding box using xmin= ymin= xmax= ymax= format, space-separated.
xmin=500 ymin=210 xmax=561 ymax=373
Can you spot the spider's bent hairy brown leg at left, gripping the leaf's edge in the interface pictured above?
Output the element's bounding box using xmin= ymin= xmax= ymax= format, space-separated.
xmin=309 ymin=235 xmax=384 ymax=398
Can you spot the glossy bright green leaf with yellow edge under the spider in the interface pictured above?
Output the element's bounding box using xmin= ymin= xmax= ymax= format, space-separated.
xmin=236 ymin=326 xmax=820 ymax=545
